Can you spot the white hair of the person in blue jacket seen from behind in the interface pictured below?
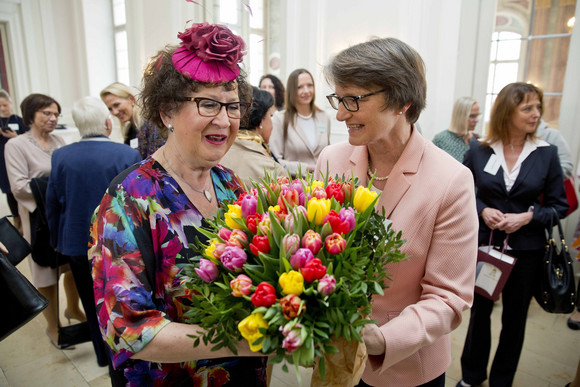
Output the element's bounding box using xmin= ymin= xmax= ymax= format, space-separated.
xmin=72 ymin=97 xmax=109 ymax=137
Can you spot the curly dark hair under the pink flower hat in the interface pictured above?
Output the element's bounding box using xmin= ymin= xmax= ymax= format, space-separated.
xmin=139 ymin=46 xmax=252 ymax=136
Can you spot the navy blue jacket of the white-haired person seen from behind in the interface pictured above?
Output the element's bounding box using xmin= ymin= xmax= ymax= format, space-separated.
xmin=46 ymin=136 xmax=141 ymax=256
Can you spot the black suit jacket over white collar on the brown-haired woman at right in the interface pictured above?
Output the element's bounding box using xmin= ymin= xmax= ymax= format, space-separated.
xmin=463 ymin=140 xmax=568 ymax=250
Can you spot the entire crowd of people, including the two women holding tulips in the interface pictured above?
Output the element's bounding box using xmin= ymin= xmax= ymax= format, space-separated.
xmin=0 ymin=23 xmax=580 ymax=387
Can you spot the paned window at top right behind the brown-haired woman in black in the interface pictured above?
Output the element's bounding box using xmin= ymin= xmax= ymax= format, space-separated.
xmin=484 ymin=0 xmax=577 ymax=128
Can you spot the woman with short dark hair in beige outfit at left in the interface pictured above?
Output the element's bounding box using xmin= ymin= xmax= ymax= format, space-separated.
xmin=5 ymin=94 xmax=86 ymax=349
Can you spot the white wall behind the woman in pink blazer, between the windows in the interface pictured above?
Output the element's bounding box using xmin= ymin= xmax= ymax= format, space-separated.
xmin=282 ymin=0 xmax=495 ymax=142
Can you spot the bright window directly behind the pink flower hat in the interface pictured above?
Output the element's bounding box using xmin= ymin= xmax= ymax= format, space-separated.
xmin=206 ymin=0 xmax=268 ymax=85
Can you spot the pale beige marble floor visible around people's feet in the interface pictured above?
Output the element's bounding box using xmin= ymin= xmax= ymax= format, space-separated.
xmin=0 ymin=194 xmax=580 ymax=387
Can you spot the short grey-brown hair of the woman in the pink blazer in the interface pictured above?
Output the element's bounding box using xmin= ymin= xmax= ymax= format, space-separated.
xmin=324 ymin=38 xmax=427 ymax=123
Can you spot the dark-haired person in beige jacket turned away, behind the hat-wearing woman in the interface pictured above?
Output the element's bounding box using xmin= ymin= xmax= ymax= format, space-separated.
xmin=220 ymin=87 xmax=286 ymax=188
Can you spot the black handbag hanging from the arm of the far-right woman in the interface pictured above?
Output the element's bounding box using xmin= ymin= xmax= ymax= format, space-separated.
xmin=534 ymin=208 xmax=576 ymax=314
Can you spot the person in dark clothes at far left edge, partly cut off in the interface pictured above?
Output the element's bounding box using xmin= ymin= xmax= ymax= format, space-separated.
xmin=0 ymin=89 xmax=28 ymax=233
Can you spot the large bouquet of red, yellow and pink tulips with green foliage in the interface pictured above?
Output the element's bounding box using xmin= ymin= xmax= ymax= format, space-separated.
xmin=183 ymin=175 xmax=403 ymax=384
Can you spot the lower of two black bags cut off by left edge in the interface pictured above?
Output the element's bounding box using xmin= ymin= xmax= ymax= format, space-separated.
xmin=0 ymin=252 xmax=48 ymax=341
